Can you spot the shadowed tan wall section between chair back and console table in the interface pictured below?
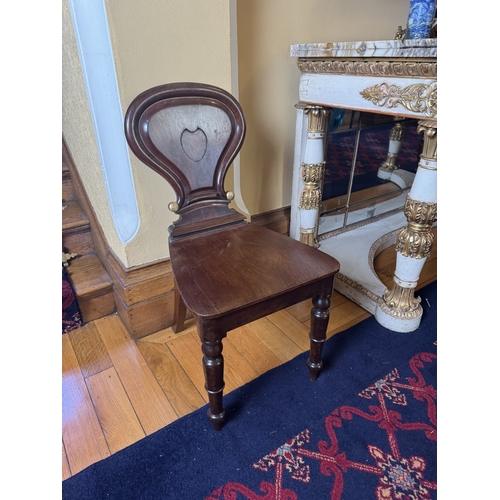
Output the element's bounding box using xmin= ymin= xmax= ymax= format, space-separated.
xmin=237 ymin=0 xmax=409 ymax=214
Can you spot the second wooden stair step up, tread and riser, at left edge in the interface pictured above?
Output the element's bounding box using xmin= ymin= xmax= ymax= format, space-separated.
xmin=62 ymin=201 xmax=95 ymax=255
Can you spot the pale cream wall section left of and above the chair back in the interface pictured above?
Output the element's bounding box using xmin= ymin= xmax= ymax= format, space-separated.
xmin=62 ymin=0 xmax=236 ymax=267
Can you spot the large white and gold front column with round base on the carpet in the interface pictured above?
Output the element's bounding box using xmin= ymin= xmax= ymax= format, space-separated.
xmin=375 ymin=120 xmax=437 ymax=333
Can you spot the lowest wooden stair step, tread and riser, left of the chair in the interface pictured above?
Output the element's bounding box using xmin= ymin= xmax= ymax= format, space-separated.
xmin=67 ymin=253 xmax=116 ymax=323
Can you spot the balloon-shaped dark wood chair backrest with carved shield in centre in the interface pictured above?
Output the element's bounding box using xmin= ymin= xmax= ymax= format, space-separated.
xmin=125 ymin=83 xmax=245 ymax=237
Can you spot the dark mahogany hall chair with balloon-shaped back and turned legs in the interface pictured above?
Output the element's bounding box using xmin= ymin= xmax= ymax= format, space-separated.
xmin=125 ymin=83 xmax=339 ymax=430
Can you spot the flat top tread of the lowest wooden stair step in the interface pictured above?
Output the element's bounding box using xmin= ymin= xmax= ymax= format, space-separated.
xmin=67 ymin=254 xmax=113 ymax=296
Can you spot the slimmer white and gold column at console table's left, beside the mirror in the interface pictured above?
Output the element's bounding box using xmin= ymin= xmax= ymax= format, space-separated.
xmin=296 ymin=104 xmax=332 ymax=247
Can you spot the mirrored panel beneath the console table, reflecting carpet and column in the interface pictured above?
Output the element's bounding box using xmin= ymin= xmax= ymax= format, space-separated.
xmin=318 ymin=109 xmax=423 ymax=237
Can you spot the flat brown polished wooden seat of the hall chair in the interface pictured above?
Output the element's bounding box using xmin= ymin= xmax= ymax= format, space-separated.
xmin=170 ymin=222 xmax=339 ymax=319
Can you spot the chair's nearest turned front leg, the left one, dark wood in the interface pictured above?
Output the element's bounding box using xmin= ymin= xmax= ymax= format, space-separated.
xmin=201 ymin=340 xmax=226 ymax=431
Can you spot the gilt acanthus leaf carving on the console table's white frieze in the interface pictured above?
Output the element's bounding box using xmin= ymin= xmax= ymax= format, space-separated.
xmin=360 ymin=82 xmax=437 ymax=118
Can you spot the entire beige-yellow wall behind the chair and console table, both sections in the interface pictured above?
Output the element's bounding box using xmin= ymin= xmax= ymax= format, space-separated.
xmin=62 ymin=0 xmax=409 ymax=267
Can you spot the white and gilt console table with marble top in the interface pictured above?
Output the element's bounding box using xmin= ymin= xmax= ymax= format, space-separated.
xmin=290 ymin=39 xmax=437 ymax=333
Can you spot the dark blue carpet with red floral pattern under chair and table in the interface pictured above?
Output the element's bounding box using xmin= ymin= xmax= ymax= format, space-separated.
xmin=62 ymin=283 xmax=437 ymax=500
